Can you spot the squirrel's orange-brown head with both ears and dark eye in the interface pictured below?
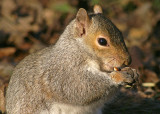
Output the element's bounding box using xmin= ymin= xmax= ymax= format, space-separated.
xmin=75 ymin=5 xmax=131 ymax=71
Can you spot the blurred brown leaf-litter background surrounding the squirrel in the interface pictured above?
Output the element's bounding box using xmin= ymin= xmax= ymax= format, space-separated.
xmin=0 ymin=0 xmax=160 ymax=114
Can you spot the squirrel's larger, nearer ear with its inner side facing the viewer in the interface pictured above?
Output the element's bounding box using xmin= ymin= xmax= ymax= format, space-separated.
xmin=76 ymin=8 xmax=89 ymax=37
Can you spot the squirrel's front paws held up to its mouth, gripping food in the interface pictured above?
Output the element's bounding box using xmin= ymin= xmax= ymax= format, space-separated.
xmin=110 ymin=67 xmax=139 ymax=85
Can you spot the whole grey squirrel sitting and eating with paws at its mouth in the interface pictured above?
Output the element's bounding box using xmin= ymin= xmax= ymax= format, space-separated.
xmin=6 ymin=5 xmax=138 ymax=114
